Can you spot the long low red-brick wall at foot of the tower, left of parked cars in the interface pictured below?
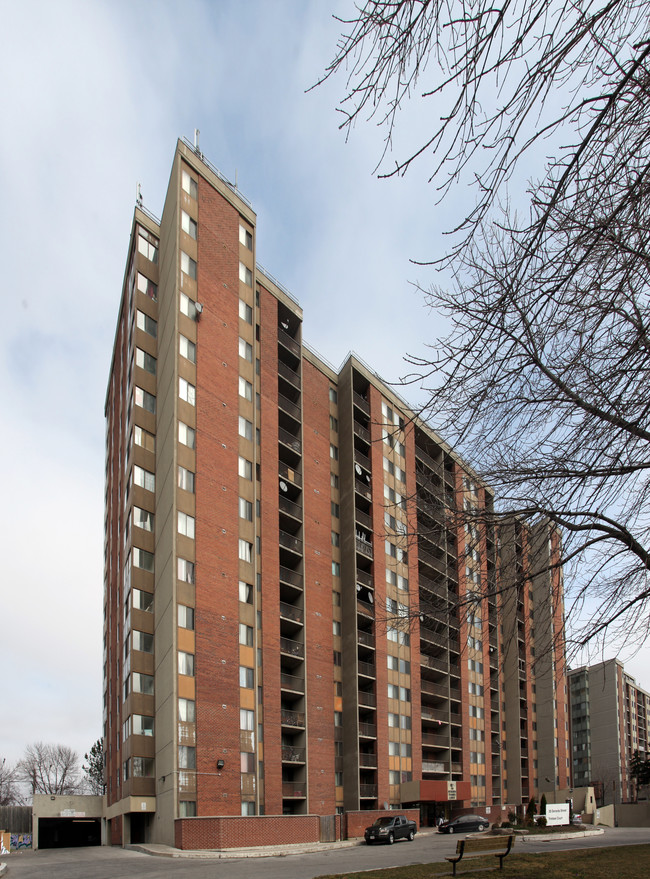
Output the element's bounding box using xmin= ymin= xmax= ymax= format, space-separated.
xmin=175 ymin=815 xmax=320 ymax=849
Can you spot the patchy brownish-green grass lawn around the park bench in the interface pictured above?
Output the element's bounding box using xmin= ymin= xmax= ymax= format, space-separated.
xmin=319 ymin=841 xmax=650 ymax=879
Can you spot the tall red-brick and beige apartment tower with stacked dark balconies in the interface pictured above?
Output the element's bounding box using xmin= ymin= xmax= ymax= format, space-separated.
xmin=104 ymin=141 xmax=568 ymax=847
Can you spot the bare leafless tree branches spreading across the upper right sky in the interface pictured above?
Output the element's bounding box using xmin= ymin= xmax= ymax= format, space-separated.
xmin=325 ymin=0 xmax=650 ymax=645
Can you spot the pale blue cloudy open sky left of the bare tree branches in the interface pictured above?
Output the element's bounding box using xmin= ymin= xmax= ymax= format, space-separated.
xmin=0 ymin=0 xmax=650 ymax=762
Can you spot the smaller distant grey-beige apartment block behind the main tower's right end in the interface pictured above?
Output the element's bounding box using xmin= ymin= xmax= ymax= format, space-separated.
xmin=568 ymin=659 xmax=650 ymax=805
